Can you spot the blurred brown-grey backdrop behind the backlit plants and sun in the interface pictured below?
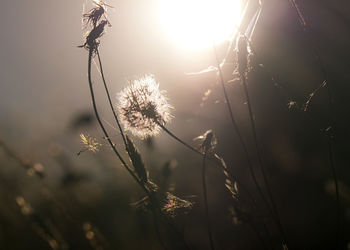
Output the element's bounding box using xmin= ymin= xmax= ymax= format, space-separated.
xmin=0 ymin=0 xmax=350 ymax=250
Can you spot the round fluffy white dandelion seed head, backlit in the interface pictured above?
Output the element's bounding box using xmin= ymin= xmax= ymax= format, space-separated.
xmin=118 ymin=75 xmax=173 ymax=139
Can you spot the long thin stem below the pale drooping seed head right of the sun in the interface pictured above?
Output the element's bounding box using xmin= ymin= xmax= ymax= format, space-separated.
xmin=241 ymin=74 xmax=287 ymax=244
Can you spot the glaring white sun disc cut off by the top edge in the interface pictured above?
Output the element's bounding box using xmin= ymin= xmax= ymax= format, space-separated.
xmin=159 ymin=0 xmax=241 ymax=49
